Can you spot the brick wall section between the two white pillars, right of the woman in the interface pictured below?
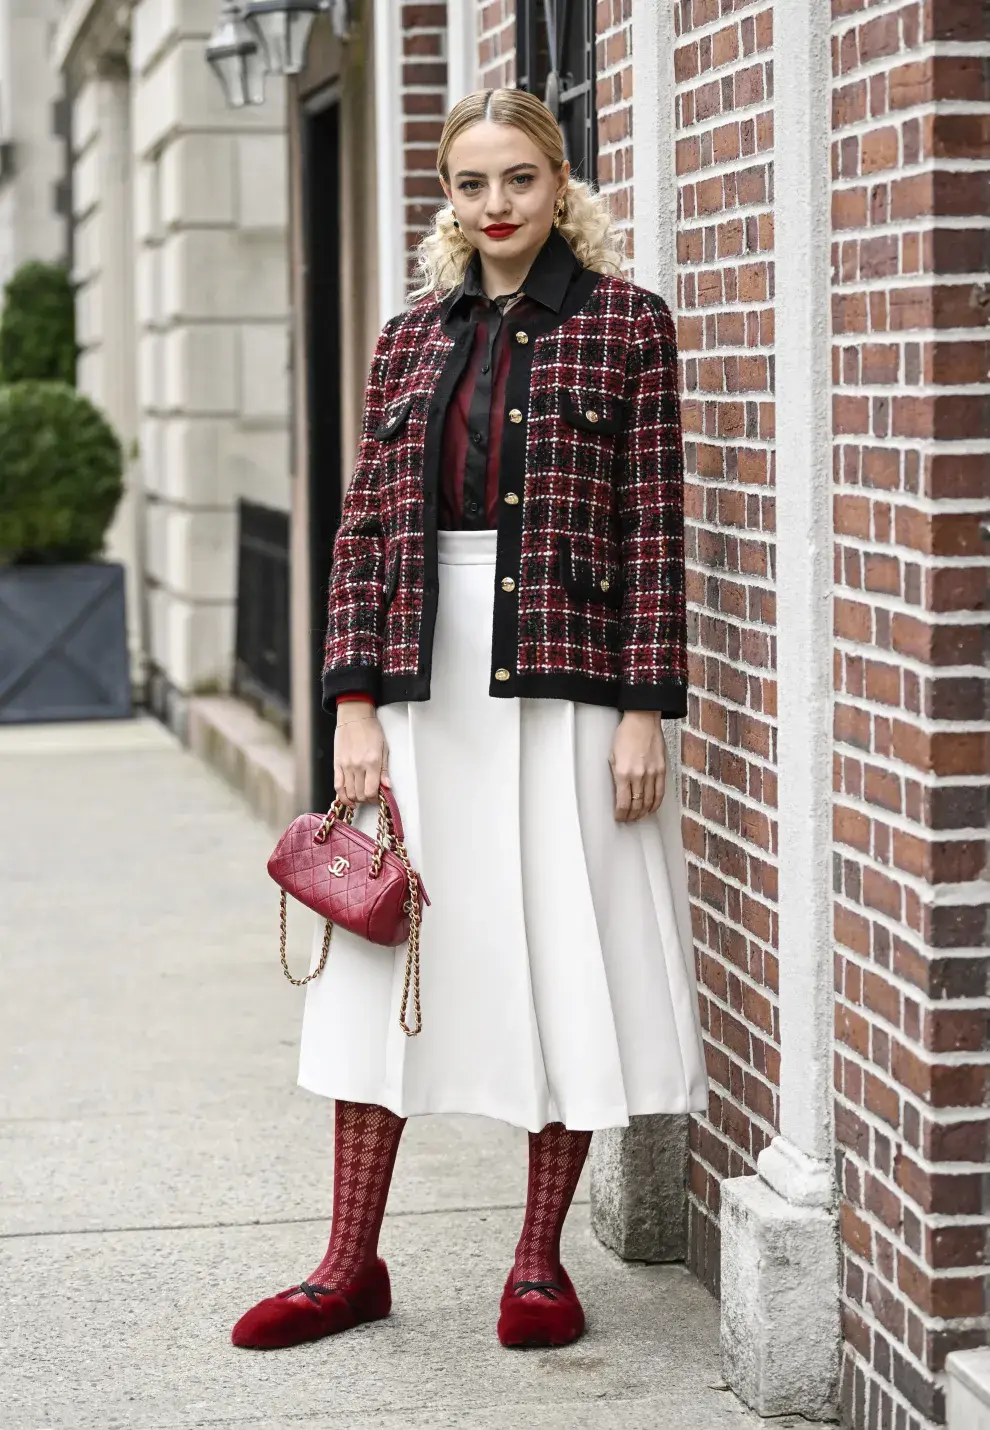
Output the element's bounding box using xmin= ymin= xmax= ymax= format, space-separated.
xmin=672 ymin=0 xmax=780 ymax=1293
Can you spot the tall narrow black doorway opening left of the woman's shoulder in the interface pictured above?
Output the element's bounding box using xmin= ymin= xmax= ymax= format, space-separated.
xmin=302 ymin=94 xmax=340 ymax=809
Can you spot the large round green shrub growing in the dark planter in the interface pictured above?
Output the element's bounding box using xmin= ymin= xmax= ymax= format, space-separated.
xmin=0 ymin=382 xmax=123 ymax=563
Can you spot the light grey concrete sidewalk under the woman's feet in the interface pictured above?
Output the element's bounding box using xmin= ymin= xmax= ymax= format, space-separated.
xmin=0 ymin=722 xmax=818 ymax=1430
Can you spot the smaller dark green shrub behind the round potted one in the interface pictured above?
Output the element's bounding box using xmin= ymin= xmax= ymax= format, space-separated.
xmin=0 ymin=263 xmax=79 ymax=388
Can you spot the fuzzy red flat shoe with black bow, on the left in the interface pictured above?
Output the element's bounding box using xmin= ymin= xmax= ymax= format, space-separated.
xmin=230 ymin=1260 xmax=392 ymax=1350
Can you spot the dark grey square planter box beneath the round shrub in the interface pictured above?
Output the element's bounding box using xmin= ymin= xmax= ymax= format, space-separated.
xmin=0 ymin=562 xmax=132 ymax=725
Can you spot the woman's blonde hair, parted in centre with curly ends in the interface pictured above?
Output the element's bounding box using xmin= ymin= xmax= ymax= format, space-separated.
xmin=412 ymin=90 xmax=622 ymax=297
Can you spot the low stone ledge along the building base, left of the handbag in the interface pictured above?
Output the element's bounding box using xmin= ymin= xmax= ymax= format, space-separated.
xmin=185 ymin=695 xmax=298 ymax=834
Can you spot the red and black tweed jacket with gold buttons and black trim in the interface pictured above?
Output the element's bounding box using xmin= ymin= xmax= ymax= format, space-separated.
xmin=323 ymin=230 xmax=687 ymax=716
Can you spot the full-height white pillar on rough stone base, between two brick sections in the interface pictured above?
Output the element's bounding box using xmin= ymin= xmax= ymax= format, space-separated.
xmin=721 ymin=4 xmax=840 ymax=1420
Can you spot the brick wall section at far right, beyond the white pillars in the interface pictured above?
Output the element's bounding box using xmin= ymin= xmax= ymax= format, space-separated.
xmin=833 ymin=0 xmax=990 ymax=1430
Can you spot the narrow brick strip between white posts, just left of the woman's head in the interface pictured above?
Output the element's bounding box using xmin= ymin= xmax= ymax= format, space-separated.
xmin=402 ymin=4 xmax=446 ymax=286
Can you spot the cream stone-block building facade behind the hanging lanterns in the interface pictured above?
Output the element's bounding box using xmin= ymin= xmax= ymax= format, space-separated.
xmin=53 ymin=0 xmax=289 ymax=712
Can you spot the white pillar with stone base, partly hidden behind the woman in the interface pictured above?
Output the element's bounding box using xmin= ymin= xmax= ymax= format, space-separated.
xmin=591 ymin=0 xmax=690 ymax=1261
